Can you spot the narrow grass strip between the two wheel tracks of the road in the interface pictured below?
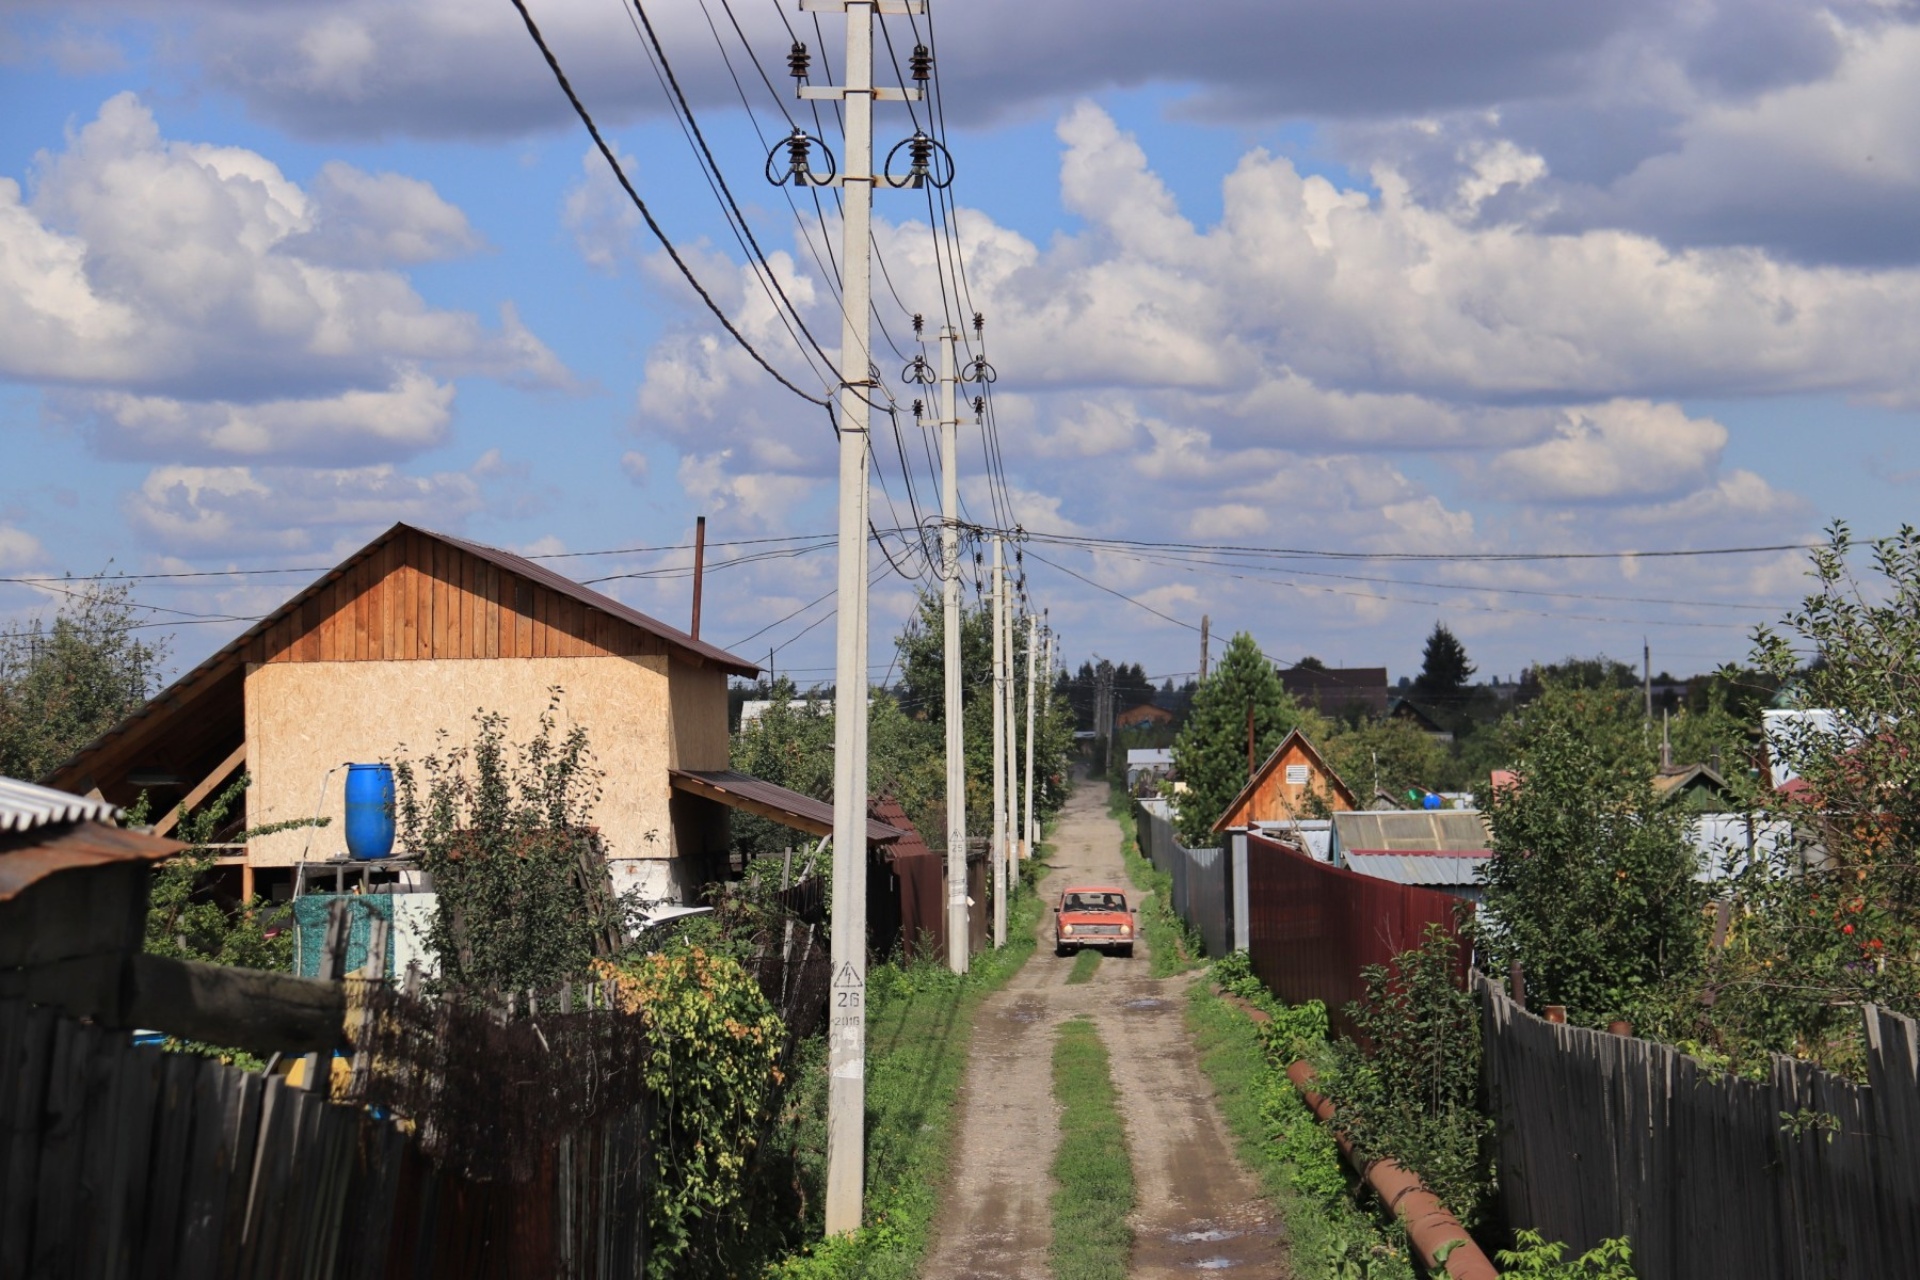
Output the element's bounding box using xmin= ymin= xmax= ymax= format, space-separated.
xmin=1048 ymin=1020 xmax=1133 ymax=1280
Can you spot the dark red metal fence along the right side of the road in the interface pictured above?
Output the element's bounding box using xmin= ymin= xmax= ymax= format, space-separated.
xmin=1246 ymin=835 xmax=1473 ymax=1032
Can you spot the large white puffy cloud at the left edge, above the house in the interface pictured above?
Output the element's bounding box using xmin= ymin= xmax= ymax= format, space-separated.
xmin=0 ymin=94 xmax=568 ymax=461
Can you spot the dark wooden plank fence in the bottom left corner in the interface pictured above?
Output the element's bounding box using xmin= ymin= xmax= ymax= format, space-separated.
xmin=0 ymin=1000 xmax=647 ymax=1280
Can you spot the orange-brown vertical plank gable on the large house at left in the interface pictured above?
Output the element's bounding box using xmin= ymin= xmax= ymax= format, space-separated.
xmin=246 ymin=533 xmax=666 ymax=662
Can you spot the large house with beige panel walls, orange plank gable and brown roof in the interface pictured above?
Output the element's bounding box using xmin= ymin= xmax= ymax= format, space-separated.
xmin=46 ymin=524 xmax=758 ymax=902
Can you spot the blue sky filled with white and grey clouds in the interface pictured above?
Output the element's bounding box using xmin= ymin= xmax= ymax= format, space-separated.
xmin=0 ymin=0 xmax=1920 ymax=685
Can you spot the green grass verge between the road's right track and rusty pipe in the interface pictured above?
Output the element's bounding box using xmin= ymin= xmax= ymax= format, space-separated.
xmin=1187 ymin=981 xmax=1415 ymax=1280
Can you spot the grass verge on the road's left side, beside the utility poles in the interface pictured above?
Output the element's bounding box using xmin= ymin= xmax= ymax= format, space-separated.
xmin=766 ymin=844 xmax=1048 ymax=1280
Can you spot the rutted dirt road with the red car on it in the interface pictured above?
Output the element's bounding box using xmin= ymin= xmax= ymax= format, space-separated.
xmin=922 ymin=779 xmax=1286 ymax=1280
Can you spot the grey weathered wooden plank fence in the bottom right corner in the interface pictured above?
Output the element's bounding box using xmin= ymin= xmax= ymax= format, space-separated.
xmin=1475 ymin=973 xmax=1920 ymax=1280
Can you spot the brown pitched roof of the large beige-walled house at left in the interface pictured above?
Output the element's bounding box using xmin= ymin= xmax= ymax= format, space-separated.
xmin=42 ymin=522 xmax=760 ymax=791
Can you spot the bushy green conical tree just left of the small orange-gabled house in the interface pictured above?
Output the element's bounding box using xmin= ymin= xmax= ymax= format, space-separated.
xmin=1173 ymin=631 xmax=1302 ymax=848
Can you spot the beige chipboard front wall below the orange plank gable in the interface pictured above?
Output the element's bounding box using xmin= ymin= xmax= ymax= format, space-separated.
xmin=246 ymin=656 xmax=675 ymax=865
